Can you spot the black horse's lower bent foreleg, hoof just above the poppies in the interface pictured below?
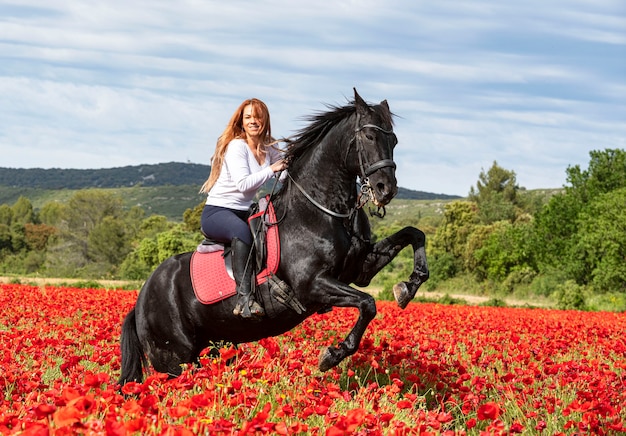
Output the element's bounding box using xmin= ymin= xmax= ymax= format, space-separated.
xmin=311 ymin=279 xmax=376 ymax=371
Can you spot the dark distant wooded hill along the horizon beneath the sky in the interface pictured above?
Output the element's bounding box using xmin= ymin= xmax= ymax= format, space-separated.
xmin=0 ymin=162 xmax=460 ymax=200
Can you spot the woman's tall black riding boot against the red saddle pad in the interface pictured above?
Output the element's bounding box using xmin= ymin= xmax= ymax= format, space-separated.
xmin=230 ymin=238 xmax=265 ymax=318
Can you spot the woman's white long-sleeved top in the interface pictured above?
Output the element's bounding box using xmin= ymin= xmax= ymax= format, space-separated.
xmin=206 ymin=139 xmax=283 ymax=210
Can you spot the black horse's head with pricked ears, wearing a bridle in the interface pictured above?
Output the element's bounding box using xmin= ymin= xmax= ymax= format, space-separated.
xmin=354 ymin=89 xmax=398 ymax=208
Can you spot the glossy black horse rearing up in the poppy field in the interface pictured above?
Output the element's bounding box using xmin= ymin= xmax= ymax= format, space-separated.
xmin=119 ymin=89 xmax=428 ymax=385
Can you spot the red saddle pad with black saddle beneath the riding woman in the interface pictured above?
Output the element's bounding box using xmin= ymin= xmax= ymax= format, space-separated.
xmin=190 ymin=196 xmax=305 ymax=316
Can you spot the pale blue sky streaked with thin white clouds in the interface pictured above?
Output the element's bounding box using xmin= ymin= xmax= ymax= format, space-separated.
xmin=0 ymin=0 xmax=626 ymax=196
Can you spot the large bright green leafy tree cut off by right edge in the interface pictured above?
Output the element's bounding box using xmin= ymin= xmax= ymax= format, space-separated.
xmin=534 ymin=149 xmax=626 ymax=292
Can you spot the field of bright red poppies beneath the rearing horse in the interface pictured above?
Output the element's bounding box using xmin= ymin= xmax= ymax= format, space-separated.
xmin=0 ymin=284 xmax=626 ymax=435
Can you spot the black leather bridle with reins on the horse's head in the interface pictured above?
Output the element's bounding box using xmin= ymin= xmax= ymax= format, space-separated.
xmin=287 ymin=124 xmax=396 ymax=218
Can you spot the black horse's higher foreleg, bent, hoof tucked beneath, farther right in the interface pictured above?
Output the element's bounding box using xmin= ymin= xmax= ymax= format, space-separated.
xmin=355 ymin=227 xmax=429 ymax=309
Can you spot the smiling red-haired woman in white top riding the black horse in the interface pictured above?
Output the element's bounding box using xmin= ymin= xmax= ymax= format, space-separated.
xmin=200 ymin=98 xmax=287 ymax=318
